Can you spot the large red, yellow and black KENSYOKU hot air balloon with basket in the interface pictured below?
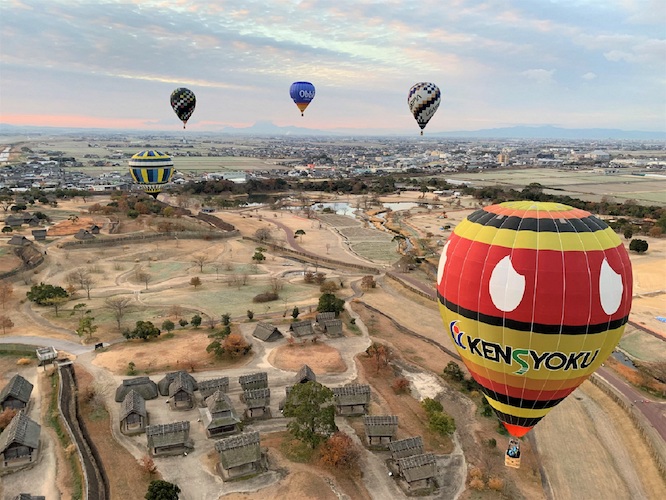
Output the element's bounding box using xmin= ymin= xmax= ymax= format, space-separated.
xmin=437 ymin=201 xmax=632 ymax=446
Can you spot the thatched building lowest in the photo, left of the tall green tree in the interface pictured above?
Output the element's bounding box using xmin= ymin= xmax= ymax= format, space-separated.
xmin=215 ymin=432 xmax=264 ymax=481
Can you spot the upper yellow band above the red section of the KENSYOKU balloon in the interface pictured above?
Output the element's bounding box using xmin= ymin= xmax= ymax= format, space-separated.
xmin=453 ymin=219 xmax=621 ymax=252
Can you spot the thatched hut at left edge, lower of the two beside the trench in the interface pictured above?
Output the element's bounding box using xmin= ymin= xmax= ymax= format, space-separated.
xmin=0 ymin=410 xmax=42 ymax=469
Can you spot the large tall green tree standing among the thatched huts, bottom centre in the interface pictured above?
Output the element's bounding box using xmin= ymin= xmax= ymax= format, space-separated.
xmin=283 ymin=381 xmax=338 ymax=449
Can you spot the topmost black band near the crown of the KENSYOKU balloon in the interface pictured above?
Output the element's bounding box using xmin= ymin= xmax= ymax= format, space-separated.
xmin=467 ymin=210 xmax=608 ymax=233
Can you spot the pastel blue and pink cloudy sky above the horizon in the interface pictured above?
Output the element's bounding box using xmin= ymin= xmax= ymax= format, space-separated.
xmin=0 ymin=0 xmax=666 ymax=134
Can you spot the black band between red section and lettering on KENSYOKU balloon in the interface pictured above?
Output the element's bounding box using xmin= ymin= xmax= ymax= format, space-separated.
xmin=437 ymin=292 xmax=629 ymax=335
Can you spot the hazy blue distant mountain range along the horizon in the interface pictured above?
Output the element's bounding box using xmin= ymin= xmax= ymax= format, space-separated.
xmin=0 ymin=122 xmax=666 ymax=141
